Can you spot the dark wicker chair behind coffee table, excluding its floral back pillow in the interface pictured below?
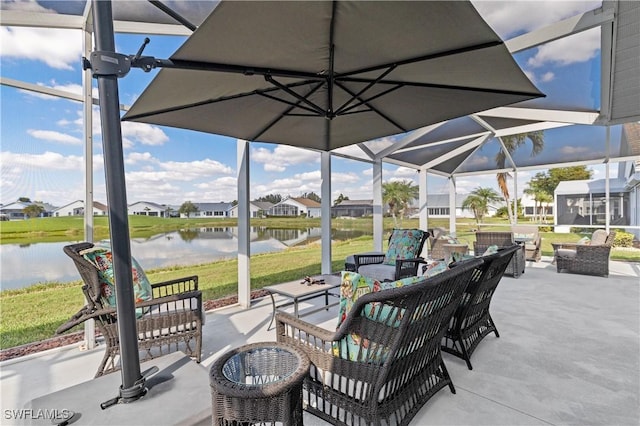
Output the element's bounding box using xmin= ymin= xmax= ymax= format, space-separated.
xmin=345 ymin=229 xmax=429 ymax=281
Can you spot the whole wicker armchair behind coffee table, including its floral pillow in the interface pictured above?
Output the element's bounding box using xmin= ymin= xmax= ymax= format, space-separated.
xmin=345 ymin=229 xmax=429 ymax=281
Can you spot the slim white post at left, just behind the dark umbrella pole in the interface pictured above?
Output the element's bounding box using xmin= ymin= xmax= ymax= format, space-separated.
xmin=82 ymin=25 xmax=96 ymax=349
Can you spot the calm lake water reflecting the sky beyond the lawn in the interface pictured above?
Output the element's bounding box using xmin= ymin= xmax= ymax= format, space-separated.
xmin=0 ymin=227 xmax=364 ymax=290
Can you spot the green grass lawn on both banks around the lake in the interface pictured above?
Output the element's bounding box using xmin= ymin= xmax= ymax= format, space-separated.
xmin=0 ymin=216 xmax=640 ymax=349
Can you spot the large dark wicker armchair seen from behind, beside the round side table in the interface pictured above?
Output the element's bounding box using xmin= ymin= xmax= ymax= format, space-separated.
xmin=276 ymin=258 xmax=482 ymax=425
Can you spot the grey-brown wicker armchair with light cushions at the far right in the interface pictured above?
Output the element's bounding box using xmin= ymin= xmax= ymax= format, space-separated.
xmin=554 ymin=230 xmax=616 ymax=277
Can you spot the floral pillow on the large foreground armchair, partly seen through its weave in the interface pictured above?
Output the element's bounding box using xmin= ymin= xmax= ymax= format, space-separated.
xmin=332 ymin=271 xmax=424 ymax=363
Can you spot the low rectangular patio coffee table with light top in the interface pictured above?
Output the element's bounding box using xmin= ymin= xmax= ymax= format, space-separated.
xmin=264 ymin=274 xmax=341 ymax=330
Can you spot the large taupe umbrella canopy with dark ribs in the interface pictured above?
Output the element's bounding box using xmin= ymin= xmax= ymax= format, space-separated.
xmin=124 ymin=1 xmax=543 ymax=151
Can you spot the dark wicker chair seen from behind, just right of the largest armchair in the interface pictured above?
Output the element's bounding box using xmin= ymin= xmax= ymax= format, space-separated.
xmin=442 ymin=244 xmax=522 ymax=370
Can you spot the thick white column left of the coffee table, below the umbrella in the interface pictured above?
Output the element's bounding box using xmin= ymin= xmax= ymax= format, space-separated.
xmin=237 ymin=139 xmax=251 ymax=308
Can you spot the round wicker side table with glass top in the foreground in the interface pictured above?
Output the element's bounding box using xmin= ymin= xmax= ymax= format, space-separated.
xmin=210 ymin=342 xmax=310 ymax=425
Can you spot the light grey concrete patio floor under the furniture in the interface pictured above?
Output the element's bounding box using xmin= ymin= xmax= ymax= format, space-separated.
xmin=0 ymin=258 xmax=640 ymax=425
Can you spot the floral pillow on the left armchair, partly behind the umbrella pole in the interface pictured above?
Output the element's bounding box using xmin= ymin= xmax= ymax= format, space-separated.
xmin=80 ymin=247 xmax=153 ymax=318
